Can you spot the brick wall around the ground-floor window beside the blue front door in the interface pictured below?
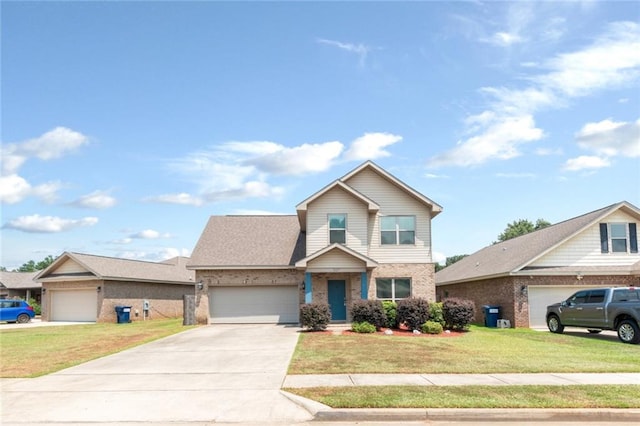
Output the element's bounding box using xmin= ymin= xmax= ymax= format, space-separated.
xmin=369 ymin=263 xmax=436 ymax=302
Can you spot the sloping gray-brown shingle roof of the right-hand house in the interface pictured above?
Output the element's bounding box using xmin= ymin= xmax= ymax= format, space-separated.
xmin=436 ymin=202 xmax=638 ymax=285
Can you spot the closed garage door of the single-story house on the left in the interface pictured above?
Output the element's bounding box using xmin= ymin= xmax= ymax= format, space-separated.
xmin=50 ymin=289 xmax=98 ymax=321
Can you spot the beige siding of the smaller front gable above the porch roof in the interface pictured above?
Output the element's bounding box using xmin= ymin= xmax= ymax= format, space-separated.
xmin=307 ymin=188 xmax=367 ymax=255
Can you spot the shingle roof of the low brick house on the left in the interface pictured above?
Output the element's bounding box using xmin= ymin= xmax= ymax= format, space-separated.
xmin=37 ymin=252 xmax=193 ymax=284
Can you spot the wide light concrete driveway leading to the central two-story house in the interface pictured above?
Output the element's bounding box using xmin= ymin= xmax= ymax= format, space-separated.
xmin=1 ymin=324 xmax=313 ymax=425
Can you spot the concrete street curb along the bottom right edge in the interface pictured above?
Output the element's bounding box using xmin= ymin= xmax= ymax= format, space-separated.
xmin=314 ymin=408 xmax=640 ymax=423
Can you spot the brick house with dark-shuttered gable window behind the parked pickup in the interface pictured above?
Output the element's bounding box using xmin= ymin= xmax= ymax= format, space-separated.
xmin=436 ymin=201 xmax=640 ymax=327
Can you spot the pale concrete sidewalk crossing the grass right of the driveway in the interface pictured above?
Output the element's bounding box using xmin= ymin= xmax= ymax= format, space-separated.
xmin=282 ymin=373 xmax=640 ymax=388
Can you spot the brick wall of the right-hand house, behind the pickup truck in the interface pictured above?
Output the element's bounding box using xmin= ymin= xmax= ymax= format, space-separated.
xmin=436 ymin=275 xmax=640 ymax=327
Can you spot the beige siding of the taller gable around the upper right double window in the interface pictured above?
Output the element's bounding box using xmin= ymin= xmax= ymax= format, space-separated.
xmin=345 ymin=170 xmax=431 ymax=263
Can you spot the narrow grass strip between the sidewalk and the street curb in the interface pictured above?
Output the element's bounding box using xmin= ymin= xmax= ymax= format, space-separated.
xmin=284 ymin=385 xmax=640 ymax=408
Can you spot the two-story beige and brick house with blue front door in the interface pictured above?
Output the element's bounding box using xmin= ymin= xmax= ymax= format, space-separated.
xmin=187 ymin=161 xmax=442 ymax=323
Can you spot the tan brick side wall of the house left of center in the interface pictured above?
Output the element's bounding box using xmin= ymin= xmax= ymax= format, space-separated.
xmin=98 ymin=281 xmax=195 ymax=322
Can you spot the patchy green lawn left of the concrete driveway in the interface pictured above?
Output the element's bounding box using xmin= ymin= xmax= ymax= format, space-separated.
xmin=0 ymin=319 xmax=192 ymax=377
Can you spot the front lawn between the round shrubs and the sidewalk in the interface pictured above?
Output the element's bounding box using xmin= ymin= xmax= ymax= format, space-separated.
xmin=289 ymin=326 xmax=640 ymax=374
